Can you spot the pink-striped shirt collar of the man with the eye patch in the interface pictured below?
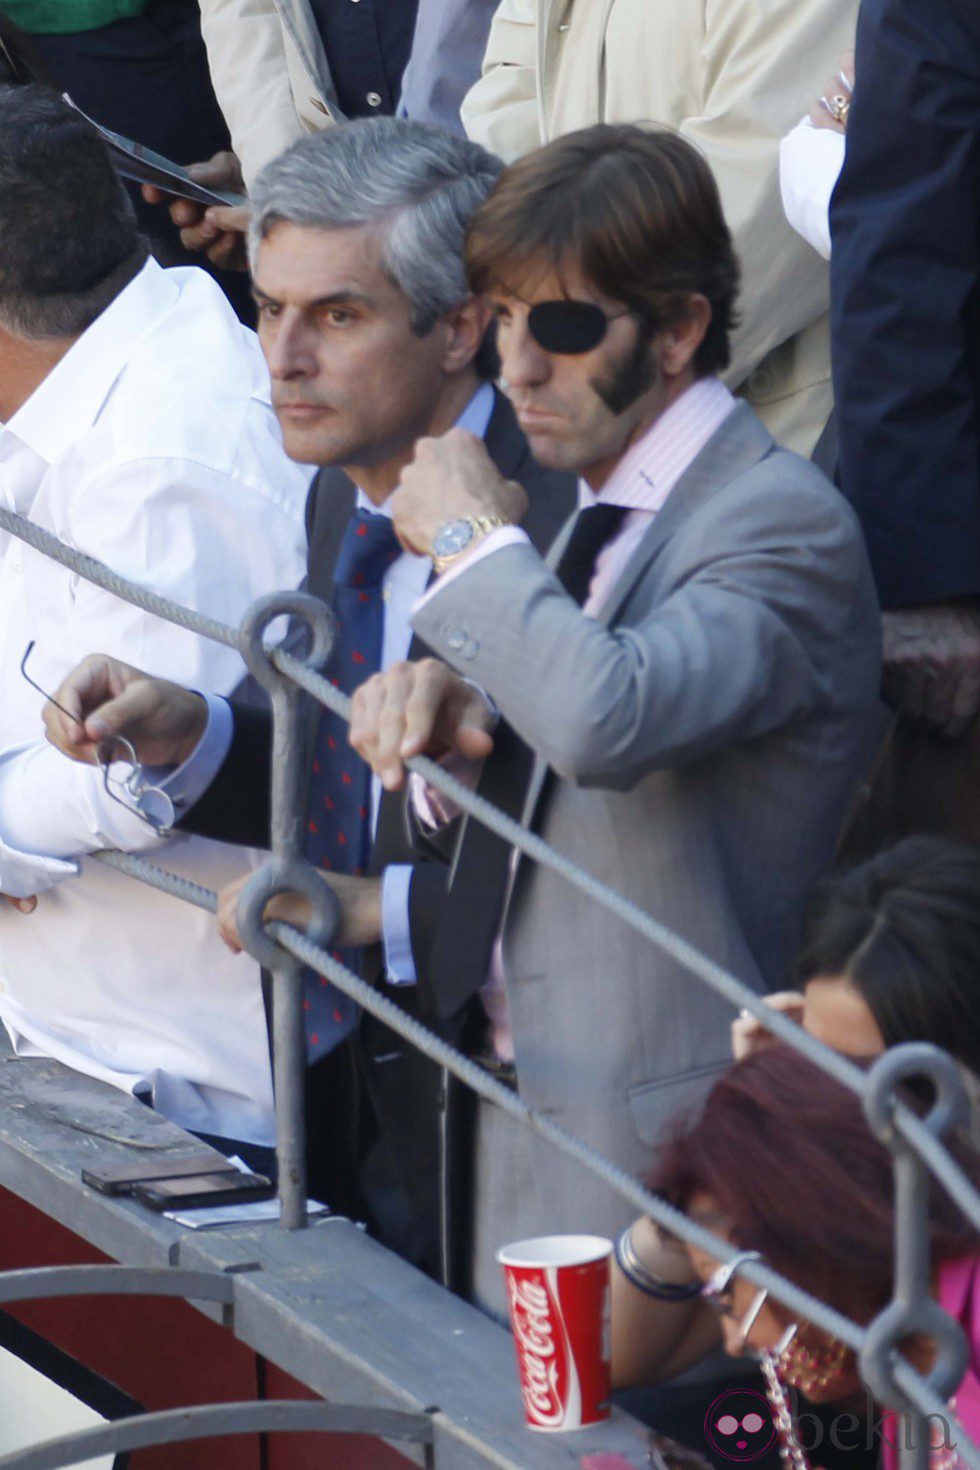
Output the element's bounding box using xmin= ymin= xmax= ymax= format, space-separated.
xmin=579 ymin=378 xmax=735 ymax=515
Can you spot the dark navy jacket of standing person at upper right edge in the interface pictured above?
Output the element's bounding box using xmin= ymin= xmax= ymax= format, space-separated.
xmin=830 ymin=0 xmax=980 ymax=607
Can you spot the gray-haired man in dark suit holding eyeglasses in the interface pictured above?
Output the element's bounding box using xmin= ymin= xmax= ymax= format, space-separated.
xmin=42 ymin=118 xmax=574 ymax=1269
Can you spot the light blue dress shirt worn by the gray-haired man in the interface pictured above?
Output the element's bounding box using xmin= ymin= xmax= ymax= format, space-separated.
xmin=154 ymin=382 xmax=494 ymax=985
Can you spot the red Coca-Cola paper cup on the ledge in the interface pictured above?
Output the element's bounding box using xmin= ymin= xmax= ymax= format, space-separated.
xmin=497 ymin=1235 xmax=613 ymax=1432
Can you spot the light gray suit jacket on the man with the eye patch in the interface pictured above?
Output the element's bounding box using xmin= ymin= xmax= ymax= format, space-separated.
xmin=414 ymin=404 xmax=882 ymax=1264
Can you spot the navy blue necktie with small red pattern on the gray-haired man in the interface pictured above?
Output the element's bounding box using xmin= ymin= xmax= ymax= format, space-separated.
xmin=303 ymin=510 xmax=401 ymax=1061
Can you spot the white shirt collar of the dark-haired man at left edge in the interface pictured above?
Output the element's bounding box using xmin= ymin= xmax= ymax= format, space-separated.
xmin=0 ymin=259 xmax=179 ymax=465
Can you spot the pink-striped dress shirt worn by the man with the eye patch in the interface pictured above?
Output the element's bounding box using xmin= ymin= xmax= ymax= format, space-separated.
xmin=410 ymin=378 xmax=735 ymax=1061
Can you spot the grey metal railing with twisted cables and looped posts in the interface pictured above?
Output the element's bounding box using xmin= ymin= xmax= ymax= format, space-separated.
xmin=0 ymin=509 xmax=980 ymax=1470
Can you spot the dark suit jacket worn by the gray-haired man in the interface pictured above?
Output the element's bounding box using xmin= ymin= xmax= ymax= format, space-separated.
xmin=179 ymin=394 xmax=576 ymax=1270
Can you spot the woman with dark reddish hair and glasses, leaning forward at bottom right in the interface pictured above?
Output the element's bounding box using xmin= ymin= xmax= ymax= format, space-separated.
xmin=613 ymin=1047 xmax=980 ymax=1470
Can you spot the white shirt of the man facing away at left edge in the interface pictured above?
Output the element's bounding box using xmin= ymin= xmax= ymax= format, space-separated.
xmin=0 ymin=260 xmax=311 ymax=1144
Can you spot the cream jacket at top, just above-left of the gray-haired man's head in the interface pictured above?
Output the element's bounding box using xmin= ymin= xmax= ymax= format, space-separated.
xmin=200 ymin=0 xmax=337 ymax=188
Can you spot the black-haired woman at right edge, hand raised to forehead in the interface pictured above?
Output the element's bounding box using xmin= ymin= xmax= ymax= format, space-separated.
xmin=732 ymin=836 xmax=980 ymax=1141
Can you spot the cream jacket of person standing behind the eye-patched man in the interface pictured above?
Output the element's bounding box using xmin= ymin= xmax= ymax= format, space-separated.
xmin=463 ymin=0 xmax=858 ymax=454
